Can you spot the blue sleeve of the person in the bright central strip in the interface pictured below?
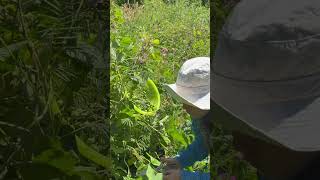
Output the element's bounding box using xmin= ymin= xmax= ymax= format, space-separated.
xmin=175 ymin=120 xmax=209 ymax=168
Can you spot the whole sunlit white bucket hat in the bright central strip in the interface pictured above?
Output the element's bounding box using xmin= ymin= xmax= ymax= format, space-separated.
xmin=164 ymin=57 xmax=210 ymax=110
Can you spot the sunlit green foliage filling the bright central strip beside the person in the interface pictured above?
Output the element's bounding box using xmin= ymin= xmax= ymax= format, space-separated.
xmin=110 ymin=0 xmax=210 ymax=179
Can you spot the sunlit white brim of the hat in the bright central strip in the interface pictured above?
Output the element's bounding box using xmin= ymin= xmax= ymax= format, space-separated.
xmin=164 ymin=84 xmax=210 ymax=110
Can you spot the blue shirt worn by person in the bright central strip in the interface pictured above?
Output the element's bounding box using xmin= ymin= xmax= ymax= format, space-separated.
xmin=175 ymin=120 xmax=210 ymax=180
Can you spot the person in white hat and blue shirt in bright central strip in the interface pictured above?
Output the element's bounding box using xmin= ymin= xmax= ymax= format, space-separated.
xmin=161 ymin=57 xmax=210 ymax=180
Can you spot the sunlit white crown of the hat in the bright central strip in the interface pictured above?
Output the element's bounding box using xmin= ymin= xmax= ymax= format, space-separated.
xmin=176 ymin=57 xmax=210 ymax=88
